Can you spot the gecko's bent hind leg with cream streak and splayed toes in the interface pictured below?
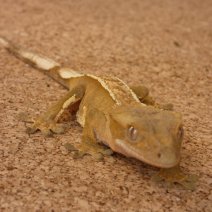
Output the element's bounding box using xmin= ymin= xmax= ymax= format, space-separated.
xmin=27 ymin=87 xmax=85 ymax=135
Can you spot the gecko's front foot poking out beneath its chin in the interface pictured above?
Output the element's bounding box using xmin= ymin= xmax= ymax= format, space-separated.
xmin=152 ymin=166 xmax=198 ymax=190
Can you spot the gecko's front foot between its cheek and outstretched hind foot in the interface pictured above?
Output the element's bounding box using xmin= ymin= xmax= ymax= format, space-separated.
xmin=64 ymin=142 xmax=113 ymax=161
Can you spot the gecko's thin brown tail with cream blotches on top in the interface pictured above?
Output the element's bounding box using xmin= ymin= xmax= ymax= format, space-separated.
xmin=0 ymin=37 xmax=82 ymax=89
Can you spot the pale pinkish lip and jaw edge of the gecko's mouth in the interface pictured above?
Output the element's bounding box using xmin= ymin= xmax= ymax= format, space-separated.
xmin=115 ymin=139 xmax=180 ymax=168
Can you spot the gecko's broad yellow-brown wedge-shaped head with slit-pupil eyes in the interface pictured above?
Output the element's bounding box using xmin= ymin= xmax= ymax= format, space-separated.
xmin=110 ymin=105 xmax=183 ymax=168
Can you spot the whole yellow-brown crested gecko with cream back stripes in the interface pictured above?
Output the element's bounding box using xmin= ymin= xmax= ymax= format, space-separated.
xmin=0 ymin=37 xmax=195 ymax=189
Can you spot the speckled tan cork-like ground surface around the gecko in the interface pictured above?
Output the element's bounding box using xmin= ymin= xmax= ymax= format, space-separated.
xmin=0 ymin=0 xmax=212 ymax=212
